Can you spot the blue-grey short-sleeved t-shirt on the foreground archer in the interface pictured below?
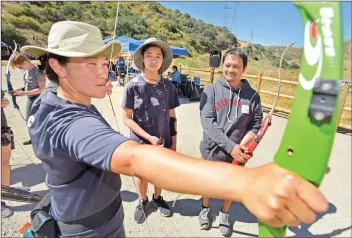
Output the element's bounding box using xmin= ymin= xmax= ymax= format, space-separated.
xmin=28 ymin=91 xmax=128 ymax=237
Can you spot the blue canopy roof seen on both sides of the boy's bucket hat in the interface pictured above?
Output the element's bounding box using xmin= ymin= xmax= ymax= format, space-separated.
xmin=104 ymin=36 xmax=188 ymax=56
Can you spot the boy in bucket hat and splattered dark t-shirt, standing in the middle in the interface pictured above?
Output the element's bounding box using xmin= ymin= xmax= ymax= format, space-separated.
xmin=122 ymin=38 xmax=180 ymax=223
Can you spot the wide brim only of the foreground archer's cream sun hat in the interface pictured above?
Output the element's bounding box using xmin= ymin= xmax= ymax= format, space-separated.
xmin=21 ymin=41 xmax=122 ymax=59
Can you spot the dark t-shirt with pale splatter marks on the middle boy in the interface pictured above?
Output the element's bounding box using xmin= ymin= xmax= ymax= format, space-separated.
xmin=122 ymin=74 xmax=180 ymax=148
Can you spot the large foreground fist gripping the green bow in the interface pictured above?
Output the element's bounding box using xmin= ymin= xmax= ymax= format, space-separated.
xmin=241 ymin=163 xmax=328 ymax=227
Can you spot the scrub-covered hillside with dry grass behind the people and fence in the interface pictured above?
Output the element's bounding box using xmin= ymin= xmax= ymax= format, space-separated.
xmin=1 ymin=1 xmax=352 ymax=128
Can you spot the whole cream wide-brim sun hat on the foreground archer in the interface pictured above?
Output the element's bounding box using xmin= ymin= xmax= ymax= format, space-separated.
xmin=21 ymin=21 xmax=121 ymax=59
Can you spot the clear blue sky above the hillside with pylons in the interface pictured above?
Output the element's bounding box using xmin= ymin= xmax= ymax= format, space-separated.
xmin=160 ymin=1 xmax=352 ymax=47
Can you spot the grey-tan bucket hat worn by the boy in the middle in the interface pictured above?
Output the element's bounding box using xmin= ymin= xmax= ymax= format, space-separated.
xmin=133 ymin=38 xmax=173 ymax=74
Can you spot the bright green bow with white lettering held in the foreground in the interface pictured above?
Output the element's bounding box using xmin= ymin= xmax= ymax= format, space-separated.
xmin=258 ymin=2 xmax=343 ymax=237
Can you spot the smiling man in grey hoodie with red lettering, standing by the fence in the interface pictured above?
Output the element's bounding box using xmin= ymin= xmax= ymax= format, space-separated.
xmin=199 ymin=49 xmax=263 ymax=236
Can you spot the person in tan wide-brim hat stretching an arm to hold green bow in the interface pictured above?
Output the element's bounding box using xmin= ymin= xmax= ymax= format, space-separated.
xmin=22 ymin=21 xmax=327 ymax=237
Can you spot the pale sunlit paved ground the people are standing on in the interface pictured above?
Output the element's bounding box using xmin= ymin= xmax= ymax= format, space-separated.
xmin=1 ymin=67 xmax=352 ymax=237
